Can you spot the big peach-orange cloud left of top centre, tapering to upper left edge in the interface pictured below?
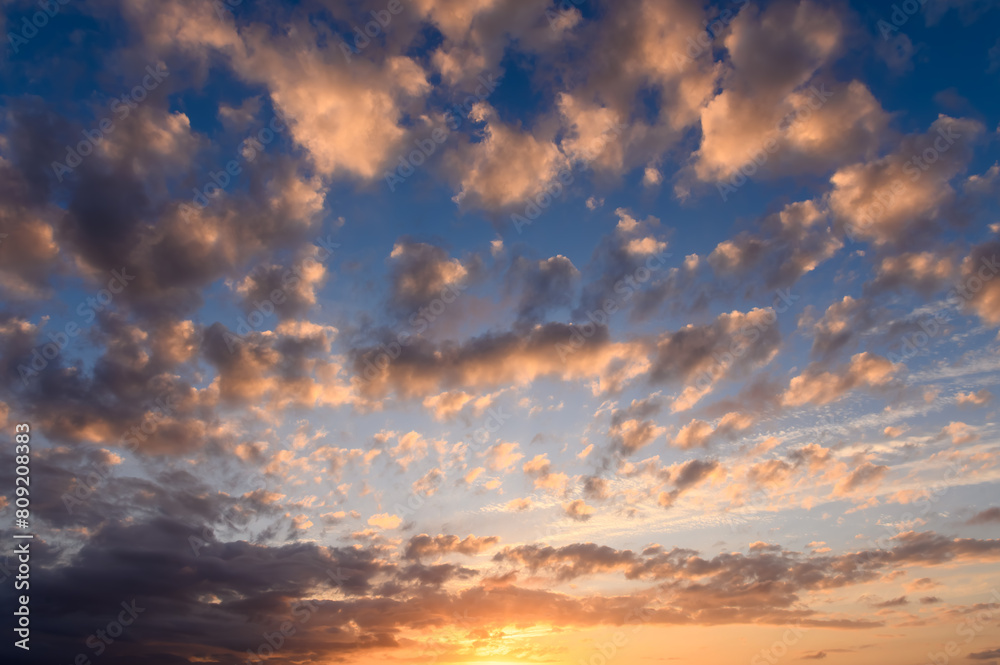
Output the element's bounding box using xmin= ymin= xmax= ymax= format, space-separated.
xmin=126 ymin=0 xmax=438 ymax=179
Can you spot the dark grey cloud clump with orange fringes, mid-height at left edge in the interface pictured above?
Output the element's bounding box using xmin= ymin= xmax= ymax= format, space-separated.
xmin=6 ymin=312 xmax=249 ymax=455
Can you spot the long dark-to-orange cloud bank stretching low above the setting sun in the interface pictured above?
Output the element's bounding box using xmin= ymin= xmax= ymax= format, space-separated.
xmin=9 ymin=506 xmax=1000 ymax=662
